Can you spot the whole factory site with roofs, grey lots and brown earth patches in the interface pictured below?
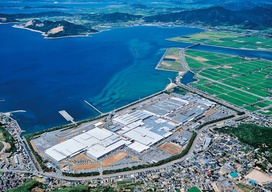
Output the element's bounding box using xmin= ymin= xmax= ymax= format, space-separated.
xmin=32 ymin=93 xmax=232 ymax=171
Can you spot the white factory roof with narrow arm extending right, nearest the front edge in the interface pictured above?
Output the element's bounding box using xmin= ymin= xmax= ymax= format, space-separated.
xmin=87 ymin=140 xmax=130 ymax=159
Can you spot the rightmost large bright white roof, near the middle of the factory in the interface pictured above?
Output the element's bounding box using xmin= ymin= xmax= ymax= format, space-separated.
xmin=124 ymin=127 xmax=163 ymax=146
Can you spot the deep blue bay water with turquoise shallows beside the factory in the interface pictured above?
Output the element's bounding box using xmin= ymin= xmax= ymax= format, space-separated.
xmin=0 ymin=24 xmax=271 ymax=133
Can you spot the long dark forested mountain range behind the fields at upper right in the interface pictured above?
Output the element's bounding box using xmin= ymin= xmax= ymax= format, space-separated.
xmin=145 ymin=7 xmax=272 ymax=29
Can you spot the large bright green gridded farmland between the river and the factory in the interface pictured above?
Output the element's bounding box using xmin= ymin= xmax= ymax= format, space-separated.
xmin=186 ymin=50 xmax=272 ymax=115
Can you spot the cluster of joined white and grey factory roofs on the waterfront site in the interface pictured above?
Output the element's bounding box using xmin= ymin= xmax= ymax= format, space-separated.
xmin=45 ymin=94 xmax=212 ymax=162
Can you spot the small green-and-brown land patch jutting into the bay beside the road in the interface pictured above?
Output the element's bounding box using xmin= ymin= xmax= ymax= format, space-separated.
xmin=157 ymin=48 xmax=184 ymax=71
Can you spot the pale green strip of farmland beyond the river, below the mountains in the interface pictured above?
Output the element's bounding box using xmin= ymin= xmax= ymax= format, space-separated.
xmin=169 ymin=31 xmax=272 ymax=51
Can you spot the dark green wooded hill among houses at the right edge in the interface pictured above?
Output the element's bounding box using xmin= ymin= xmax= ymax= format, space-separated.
xmin=215 ymin=124 xmax=272 ymax=163
